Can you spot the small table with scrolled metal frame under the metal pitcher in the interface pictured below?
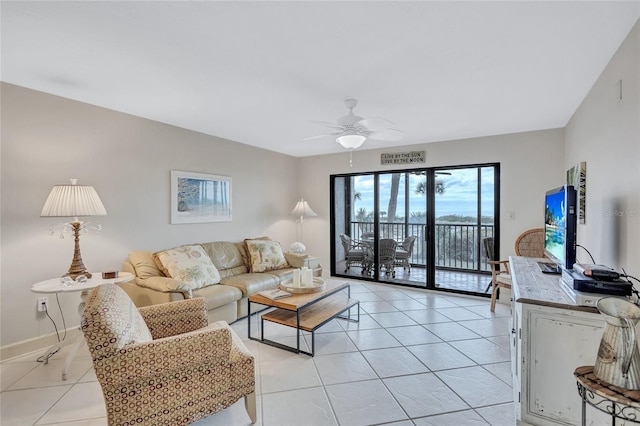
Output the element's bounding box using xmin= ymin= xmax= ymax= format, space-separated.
xmin=573 ymin=365 xmax=640 ymax=426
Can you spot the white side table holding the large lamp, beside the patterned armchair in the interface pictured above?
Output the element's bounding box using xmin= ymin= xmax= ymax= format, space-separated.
xmin=31 ymin=272 xmax=134 ymax=380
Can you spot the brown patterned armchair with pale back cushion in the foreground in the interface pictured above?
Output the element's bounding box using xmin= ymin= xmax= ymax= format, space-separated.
xmin=82 ymin=284 xmax=256 ymax=425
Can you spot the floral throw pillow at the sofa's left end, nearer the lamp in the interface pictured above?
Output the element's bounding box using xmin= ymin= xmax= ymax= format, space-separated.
xmin=153 ymin=245 xmax=220 ymax=291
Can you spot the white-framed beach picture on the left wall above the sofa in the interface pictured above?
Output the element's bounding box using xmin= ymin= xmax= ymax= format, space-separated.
xmin=171 ymin=170 xmax=232 ymax=224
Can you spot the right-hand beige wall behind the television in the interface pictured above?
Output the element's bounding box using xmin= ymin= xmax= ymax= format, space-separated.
xmin=565 ymin=19 xmax=640 ymax=272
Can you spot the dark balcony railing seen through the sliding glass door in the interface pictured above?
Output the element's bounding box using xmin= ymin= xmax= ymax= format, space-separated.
xmin=351 ymin=222 xmax=494 ymax=271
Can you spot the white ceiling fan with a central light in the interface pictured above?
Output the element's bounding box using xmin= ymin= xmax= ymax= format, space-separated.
xmin=304 ymin=99 xmax=404 ymax=149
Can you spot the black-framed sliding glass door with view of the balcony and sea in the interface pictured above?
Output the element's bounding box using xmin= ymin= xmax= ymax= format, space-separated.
xmin=331 ymin=164 xmax=500 ymax=295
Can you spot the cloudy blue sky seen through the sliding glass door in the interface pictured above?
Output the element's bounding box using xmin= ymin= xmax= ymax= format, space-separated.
xmin=354 ymin=168 xmax=494 ymax=217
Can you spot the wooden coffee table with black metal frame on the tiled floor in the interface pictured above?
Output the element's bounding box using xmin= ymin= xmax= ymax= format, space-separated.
xmin=247 ymin=282 xmax=360 ymax=356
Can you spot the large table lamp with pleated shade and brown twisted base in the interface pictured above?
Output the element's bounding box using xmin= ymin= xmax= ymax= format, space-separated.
xmin=40 ymin=179 xmax=107 ymax=280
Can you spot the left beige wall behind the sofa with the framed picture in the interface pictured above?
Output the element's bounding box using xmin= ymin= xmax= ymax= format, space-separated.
xmin=0 ymin=84 xmax=298 ymax=346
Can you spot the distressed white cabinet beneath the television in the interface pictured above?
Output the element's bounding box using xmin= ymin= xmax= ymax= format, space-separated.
xmin=510 ymin=257 xmax=605 ymax=425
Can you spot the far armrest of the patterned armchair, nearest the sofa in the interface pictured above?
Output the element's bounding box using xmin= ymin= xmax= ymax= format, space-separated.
xmin=138 ymin=297 xmax=208 ymax=339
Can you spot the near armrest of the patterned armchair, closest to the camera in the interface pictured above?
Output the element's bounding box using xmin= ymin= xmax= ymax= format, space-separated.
xmin=94 ymin=321 xmax=232 ymax=386
